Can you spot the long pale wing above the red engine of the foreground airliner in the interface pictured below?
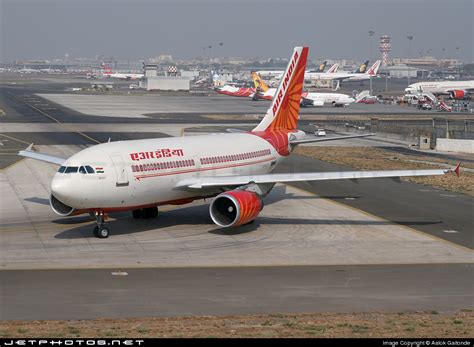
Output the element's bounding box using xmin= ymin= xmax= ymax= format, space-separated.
xmin=176 ymin=164 xmax=459 ymax=189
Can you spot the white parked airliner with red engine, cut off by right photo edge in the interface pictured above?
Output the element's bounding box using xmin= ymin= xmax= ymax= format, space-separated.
xmin=405 ymin=81 xmax=474 ymax=99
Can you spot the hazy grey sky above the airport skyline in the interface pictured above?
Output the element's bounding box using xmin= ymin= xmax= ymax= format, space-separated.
xmin=0 ymin=0 xmax=474 ymax=61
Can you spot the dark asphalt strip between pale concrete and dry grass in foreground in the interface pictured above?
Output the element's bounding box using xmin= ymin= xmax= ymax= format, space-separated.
xmin=0 ymin=264 xmax=474 ymax=320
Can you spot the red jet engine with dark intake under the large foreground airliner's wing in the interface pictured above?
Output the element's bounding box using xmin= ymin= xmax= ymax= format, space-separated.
xmin=209 ymin=190 xmax=263 ymax=227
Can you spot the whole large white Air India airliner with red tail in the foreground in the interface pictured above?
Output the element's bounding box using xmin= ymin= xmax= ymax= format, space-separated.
xmin=19 ymin=47 xmax=459 ymax=238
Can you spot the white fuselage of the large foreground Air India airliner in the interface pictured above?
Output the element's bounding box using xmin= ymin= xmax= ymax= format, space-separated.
xmin=51 ymin=133 xmax=284 ymax=212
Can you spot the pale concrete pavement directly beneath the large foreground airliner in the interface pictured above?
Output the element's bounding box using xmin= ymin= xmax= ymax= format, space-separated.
xmin=0 ymin=152 xmax=473 ymax=269
